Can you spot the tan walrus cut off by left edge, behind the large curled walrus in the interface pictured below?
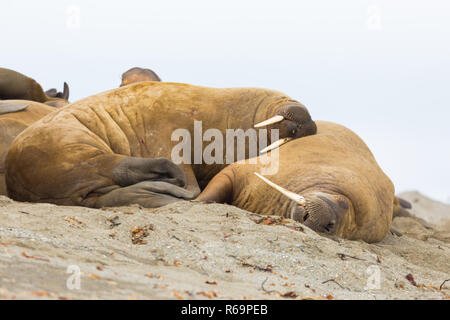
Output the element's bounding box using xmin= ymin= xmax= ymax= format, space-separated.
xmin=0 ymin=100 xmax=55 ymax=195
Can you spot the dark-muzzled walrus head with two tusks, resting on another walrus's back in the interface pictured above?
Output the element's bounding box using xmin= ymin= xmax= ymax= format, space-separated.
xmin=254 ymin=102 xmax=317 ymax=153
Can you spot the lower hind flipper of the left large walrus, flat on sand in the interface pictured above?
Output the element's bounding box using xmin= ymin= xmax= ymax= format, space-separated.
xmin=95 ymin=181 xmax=195 ymax=208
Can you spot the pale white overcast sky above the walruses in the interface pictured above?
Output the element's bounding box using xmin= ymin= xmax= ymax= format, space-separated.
xmin=0 ymin=0 xmax=450 ymax=203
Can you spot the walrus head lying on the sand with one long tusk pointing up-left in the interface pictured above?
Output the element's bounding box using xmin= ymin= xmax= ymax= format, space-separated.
xmin=255 ymin=172 xmax=350 ymax=235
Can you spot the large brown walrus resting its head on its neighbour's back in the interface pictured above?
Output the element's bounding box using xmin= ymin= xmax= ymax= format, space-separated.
xmin=6 ymin=81 xmax=316 ymax=208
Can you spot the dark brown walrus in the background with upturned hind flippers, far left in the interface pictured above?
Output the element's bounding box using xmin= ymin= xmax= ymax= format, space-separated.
xmin=0 ymin=68 xmax=69 ymax=108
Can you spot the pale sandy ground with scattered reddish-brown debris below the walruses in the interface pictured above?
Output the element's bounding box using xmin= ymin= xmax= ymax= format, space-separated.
xmin=0 ymin=193 xmax=450 ymax=299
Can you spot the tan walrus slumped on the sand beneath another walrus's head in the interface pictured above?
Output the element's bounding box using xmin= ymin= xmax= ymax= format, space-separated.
xmin=197 ymin=121 xmax=397 ymax=243
